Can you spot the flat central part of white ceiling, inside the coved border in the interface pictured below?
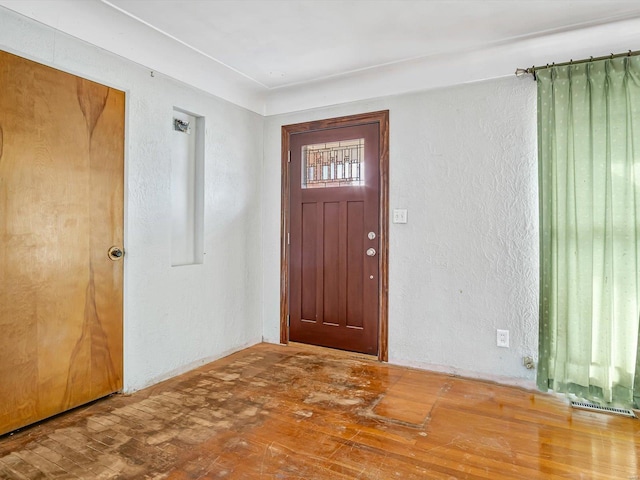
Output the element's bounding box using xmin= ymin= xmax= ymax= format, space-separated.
xmin=105 ymin=0 xmax=640 ymax=88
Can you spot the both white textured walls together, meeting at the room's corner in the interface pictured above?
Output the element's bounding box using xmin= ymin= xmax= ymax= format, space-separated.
xmin=0 ymin=3 xmax=538 ymax=391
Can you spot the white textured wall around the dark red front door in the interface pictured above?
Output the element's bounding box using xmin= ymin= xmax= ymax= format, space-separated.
xmin=263 ymin=76 xmax=538 ymax=386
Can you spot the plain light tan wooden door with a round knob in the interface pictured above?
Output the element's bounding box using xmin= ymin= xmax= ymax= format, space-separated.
xmin=0 ymin=51 xmax=125 ymax=434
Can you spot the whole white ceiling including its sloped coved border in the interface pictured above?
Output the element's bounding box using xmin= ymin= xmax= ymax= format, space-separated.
xmin=0 ymin=0 xmax=640 ymax=114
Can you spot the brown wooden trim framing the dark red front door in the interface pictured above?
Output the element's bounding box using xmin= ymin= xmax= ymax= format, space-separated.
xmin=280 ymin=110 xmax=389 ymax=362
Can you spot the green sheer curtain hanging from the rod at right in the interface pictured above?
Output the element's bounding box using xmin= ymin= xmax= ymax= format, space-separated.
xmin=537 ymin=57 xmax=640 ymax=407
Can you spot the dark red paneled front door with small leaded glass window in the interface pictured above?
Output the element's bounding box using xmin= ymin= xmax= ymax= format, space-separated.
xmin=289 ymin=123 xmax=380 ymax=354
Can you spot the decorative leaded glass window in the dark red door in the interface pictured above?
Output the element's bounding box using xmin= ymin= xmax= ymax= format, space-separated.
xmin=302 ymin=138 xmax=364 ymax=188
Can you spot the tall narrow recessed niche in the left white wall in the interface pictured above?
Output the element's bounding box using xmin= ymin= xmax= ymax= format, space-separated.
xmin=171 ymin=107 xmax=205 ymax=267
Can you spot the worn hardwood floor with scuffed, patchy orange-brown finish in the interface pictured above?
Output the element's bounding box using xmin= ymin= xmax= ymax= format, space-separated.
xmin=0 ymin=344 xmax=640 ymax=480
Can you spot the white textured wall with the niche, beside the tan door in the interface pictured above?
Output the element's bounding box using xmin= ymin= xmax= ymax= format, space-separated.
xmin=0 ymin=7 xmax=263 ymax=391
